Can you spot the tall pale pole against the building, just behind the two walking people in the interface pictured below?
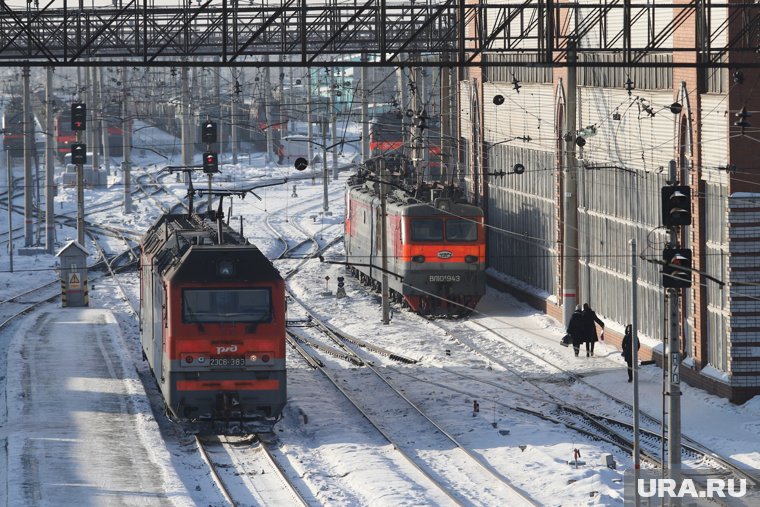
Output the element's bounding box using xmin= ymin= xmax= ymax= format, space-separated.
xmin=562 ymin=40 xmax=578 ymax=326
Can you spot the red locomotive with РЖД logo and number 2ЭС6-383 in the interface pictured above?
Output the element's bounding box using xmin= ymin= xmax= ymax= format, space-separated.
xmin=140 ymin=212 xmax=286 ymax=434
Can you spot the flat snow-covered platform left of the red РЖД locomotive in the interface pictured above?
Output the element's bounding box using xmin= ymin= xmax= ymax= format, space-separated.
xmin=0 ymin=308 xmax=186 ymax=505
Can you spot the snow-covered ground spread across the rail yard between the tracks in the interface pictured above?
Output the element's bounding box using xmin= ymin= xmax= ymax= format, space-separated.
xmin=0 ymin=120 xmax=760 ymax=506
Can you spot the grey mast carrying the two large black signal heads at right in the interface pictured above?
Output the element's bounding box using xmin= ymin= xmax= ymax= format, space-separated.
xmin=666 ymin=160 xmax=681 ymax=492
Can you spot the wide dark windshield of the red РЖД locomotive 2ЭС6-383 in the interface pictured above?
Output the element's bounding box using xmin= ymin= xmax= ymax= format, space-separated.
xmin=182 ymin=289 xmax=272 ymax=323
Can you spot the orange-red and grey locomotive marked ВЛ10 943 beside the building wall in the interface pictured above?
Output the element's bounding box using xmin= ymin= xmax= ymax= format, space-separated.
xmin=344 ymin=155 xmax=486 ymax=317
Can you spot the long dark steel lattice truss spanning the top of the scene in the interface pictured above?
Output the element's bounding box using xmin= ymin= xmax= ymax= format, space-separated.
xmin=0 ymin=0 xmax=760 ymax=68
